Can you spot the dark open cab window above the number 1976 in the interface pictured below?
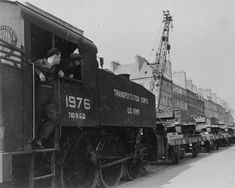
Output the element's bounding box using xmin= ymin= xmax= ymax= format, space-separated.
xmin=31 ymin=24 xmax=82 ymax=80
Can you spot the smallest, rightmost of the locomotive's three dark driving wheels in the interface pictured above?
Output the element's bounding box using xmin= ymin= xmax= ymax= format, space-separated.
xmin=126 ymin=157 xmax=142 ymax=180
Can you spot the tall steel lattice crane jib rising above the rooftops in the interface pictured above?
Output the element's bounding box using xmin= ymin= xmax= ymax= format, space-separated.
xmin=150 ymin=10 xmax=173 ymax=110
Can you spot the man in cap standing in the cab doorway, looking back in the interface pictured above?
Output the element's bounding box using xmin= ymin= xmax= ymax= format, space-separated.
xmin=33 ymin=48 xmax=64 ymax=148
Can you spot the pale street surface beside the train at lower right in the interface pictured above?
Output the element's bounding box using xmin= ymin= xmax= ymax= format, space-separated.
xmin=118 ymin=145 xmax=235 ymax=188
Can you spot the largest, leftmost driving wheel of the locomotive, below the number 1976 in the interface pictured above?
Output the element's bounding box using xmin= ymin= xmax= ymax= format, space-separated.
xmin=61 ymin=133 xmax=98 ymax=188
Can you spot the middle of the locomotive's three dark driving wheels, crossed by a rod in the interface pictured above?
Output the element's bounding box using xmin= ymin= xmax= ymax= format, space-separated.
xmin=96 ymin=136 xmax=123 ymax=188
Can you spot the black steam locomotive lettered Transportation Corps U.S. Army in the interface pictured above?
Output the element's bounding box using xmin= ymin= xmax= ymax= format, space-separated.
xmin=0 ymin=0 xmax=156 ymax=188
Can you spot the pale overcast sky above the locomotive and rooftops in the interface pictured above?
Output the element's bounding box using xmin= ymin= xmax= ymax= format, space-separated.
xmin=17 ymin=0 xmax=235 ymax=109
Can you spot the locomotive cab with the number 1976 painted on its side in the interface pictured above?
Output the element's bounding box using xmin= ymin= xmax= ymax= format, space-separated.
xmin=0 ymin=1 xmax=98 ymax=187
